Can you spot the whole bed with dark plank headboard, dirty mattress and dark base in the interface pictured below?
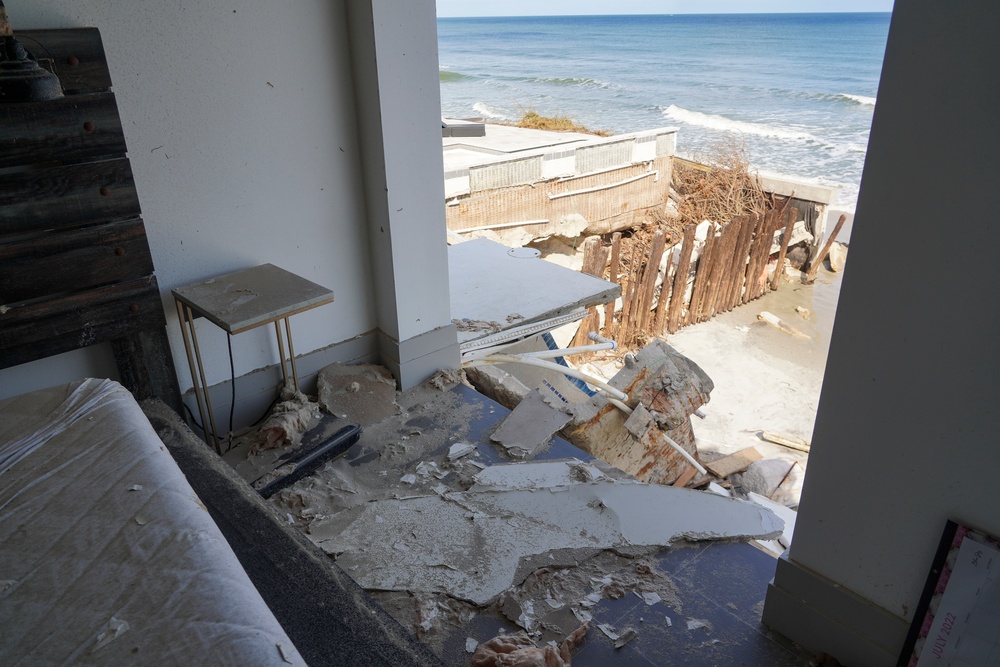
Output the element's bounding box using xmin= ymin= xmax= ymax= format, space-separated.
xmin=0 ymin=28 xmax=439 ymax=665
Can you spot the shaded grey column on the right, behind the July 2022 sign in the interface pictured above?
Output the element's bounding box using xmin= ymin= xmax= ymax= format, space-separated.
xmin=764 ymin=0 xmax=1000 ymax=665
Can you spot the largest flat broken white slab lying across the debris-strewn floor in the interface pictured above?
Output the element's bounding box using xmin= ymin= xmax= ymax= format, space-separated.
xmin=309 ymin=464 xmax=782 ymax=605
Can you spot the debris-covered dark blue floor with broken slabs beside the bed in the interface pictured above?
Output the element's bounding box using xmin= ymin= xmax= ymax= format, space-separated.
xmin=227 ymin=368 xmax=809 ymax=665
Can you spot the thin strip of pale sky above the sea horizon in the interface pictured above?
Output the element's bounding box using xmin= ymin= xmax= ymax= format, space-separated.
xmin=437 ymin=0 xmax=892 ymax=16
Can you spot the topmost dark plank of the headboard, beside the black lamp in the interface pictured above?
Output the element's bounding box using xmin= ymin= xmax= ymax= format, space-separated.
xmin=17 ymin=28 xmax=111 ymax=94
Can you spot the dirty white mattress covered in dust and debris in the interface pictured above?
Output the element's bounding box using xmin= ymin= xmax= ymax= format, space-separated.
xmin=0 ymin=380 xmax=304 ymax=665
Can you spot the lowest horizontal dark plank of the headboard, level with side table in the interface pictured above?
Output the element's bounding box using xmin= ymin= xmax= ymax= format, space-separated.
xmin=0 ymin=276 xmax=166 ymax=368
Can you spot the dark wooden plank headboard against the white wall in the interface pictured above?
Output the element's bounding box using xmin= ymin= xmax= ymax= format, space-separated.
xmin=0 ymin=28 xmax=180 ymax=409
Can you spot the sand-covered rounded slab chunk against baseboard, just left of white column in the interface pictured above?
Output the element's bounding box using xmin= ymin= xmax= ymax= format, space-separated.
xmin=316 ymin=364 xmax=400 ymax=426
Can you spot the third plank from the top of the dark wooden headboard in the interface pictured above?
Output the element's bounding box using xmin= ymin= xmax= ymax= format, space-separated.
xmin=0 ymin=158 xmax=139 ymax=234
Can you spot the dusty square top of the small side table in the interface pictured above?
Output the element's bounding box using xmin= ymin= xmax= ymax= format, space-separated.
xmin=171 ymin=264 xmax=333 ymax=334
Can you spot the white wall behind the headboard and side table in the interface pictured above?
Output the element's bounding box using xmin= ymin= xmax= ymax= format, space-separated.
xmin=0 ymin=0 xmax=376 ymax=397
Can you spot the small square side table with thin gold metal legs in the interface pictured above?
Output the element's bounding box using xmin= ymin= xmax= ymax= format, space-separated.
xmin=171 ymin=264 xmax=333 ymax=453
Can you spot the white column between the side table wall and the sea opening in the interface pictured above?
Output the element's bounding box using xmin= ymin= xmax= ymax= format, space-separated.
xmin=346 ymin=0 xmax=459 ymax=389
